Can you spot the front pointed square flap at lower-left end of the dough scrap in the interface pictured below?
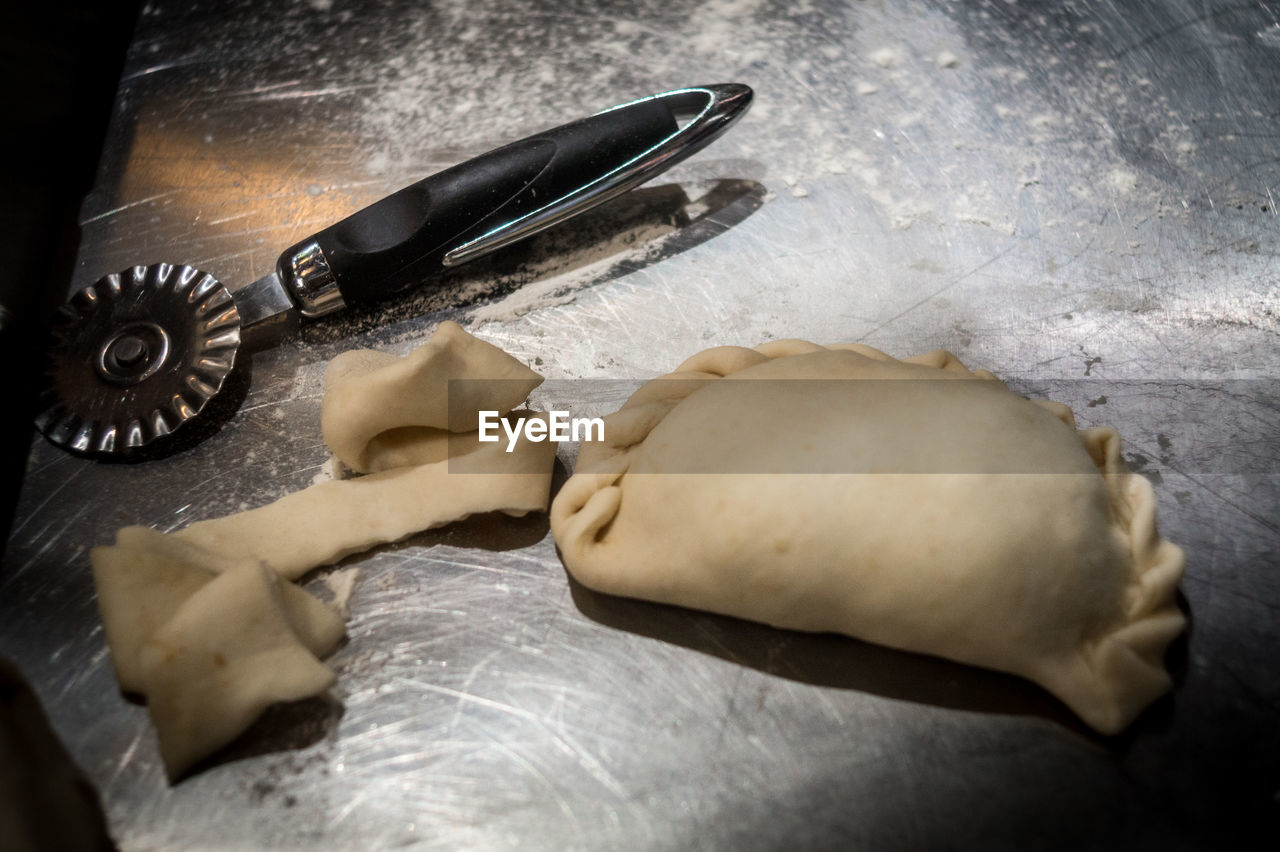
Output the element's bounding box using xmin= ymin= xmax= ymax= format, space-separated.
xmin=138 ymin=563 xmax=334 ymax=779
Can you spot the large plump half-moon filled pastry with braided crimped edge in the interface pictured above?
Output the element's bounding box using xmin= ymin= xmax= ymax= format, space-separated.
xmin=552 ymin=340 xmax=1184 ymax=733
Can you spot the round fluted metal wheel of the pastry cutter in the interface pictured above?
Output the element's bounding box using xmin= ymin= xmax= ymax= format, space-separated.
xmin=36 ymin=264 xmax=241 ymax=454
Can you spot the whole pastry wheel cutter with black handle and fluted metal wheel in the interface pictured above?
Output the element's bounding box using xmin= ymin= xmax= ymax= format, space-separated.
xmin=36 ymin=83 xmax=751 ymax=457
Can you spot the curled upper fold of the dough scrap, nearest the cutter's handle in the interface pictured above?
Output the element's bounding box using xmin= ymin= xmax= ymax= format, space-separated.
xmin=320 ymin=321 xmax=543 ymax=473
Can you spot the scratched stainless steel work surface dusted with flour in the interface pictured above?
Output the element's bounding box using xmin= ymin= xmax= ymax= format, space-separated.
xmin=0 ymin=0 xmax=1280 ymax=849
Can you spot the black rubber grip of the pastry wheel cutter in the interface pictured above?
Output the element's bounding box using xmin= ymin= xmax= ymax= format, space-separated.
xmin=280 ymin=100 xmax=677 ymax=304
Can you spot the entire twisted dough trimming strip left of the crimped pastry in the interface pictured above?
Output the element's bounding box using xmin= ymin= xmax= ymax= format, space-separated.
xmin=91 ymin=322 xmax=556 ymax=779
